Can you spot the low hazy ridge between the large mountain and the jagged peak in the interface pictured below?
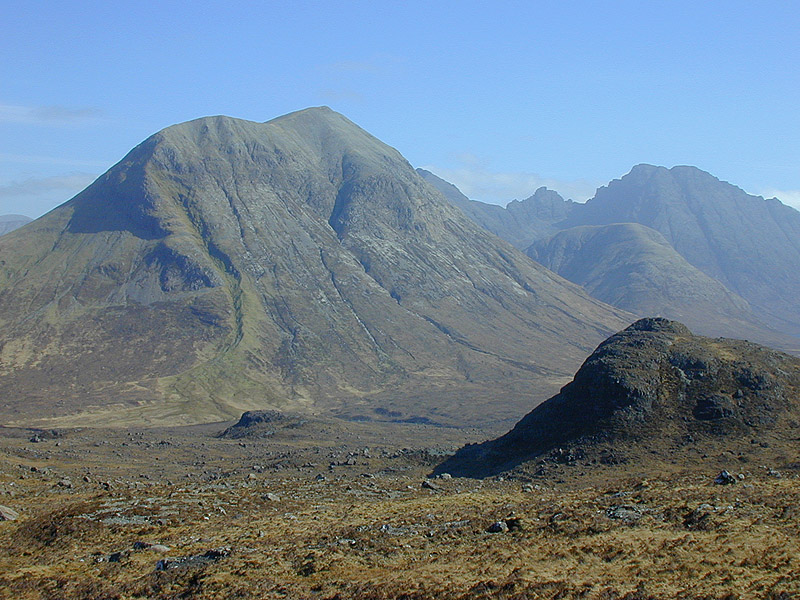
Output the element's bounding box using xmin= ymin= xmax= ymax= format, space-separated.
xmin=417 ymin=169 xmax=576 ymax=250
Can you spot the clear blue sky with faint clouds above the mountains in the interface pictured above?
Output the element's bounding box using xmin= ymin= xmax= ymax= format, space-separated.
xmin=0 ymin=0 xmax=800 ymax=217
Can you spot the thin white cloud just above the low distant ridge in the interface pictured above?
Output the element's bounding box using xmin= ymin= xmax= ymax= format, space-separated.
xmin=422 ymin=154 xmax=598 ymax=205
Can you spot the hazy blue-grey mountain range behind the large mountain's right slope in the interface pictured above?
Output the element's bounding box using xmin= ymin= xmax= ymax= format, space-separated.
xmin=420 ymin=165 xmax=800 ymax=352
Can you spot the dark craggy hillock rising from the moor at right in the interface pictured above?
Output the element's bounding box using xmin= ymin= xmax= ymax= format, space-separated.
xmin=437 ymin=319 xmax=800 ymax=477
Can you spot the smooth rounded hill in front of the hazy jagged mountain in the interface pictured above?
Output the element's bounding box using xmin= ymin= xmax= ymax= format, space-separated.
xmin=527 ymin=223 xmax=797 ymax=347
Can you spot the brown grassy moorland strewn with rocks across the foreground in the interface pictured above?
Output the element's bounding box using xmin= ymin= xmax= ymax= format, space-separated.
xmin=0 ymin=420 xmax=800 ymax=600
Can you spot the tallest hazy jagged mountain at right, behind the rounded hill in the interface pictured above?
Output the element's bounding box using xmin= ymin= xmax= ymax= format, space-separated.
xmin=560 ymin=165 xmax=800 ymax=335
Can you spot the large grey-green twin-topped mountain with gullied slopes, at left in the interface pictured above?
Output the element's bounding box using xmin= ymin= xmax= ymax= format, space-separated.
xmin=0 ymin=108 xmax=629 ymax=424
